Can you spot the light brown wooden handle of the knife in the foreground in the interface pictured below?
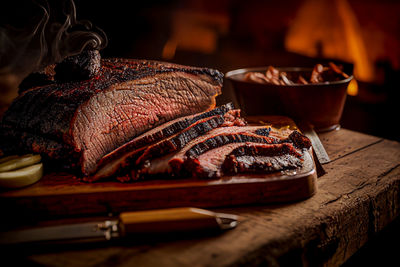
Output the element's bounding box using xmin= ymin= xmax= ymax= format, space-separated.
xmin=119 ymin=207 xmax=236 ymax=235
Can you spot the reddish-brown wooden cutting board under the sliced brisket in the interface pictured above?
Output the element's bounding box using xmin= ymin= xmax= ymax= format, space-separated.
xmin=0 ymin=116 xmax=316 ymax=218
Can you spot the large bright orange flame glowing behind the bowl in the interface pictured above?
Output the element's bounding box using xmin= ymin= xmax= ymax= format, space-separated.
xmin=285 ymin=0 xmax=374 ymax=84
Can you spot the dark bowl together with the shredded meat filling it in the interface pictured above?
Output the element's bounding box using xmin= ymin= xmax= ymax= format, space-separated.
xmin=225 ymin=64 xmax=353 ymax=132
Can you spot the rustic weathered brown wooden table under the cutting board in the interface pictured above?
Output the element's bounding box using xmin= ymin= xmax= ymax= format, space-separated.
xmin=7 ymin=129 xmax=400 ymax=266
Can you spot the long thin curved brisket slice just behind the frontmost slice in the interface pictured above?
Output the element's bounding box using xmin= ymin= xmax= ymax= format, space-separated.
xmin=140 ymin=125 xmax=278 ymax=176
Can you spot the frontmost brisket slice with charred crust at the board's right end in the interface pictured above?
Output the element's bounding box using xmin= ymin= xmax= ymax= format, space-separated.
xmin=184 ymin=131 xmax=310 ymax=178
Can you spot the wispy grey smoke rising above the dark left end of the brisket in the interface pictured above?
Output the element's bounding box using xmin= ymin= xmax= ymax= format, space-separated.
xmin=0 ymin=0 xmax=107 ymax=99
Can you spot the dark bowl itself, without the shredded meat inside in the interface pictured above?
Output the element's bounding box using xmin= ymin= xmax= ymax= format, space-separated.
xmin=225 ymin=67 xmax=353 ymax=132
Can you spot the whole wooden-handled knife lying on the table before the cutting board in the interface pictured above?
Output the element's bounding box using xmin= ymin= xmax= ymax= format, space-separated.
xmin=0 ymin=207 xmax=238 ymax=245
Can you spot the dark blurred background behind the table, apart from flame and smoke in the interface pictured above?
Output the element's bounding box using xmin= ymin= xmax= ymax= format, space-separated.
xmin=0 ymin=0 xmax=400 ymax=266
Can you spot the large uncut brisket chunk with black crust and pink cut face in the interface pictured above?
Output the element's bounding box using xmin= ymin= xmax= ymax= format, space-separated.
xmin=0 ymin=59 xmax=223 ymax=175
